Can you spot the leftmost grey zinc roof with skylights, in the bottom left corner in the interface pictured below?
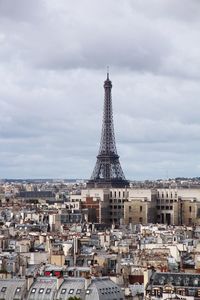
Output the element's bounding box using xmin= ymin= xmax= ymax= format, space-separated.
xmin=0 ymin=279 xmax=26 ymax=300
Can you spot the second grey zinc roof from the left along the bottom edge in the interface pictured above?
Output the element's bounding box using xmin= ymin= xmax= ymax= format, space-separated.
xmin=27 ymin=277 xmax=57 ymax=300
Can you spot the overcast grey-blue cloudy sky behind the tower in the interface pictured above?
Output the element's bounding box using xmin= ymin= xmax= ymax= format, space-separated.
xmin=0 ymin=0 xmax=200 ymax=180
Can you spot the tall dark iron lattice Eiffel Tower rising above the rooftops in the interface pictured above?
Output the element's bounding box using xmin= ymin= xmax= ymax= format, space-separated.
xmin=87 ymin=73 xmax=129 ymax=187
